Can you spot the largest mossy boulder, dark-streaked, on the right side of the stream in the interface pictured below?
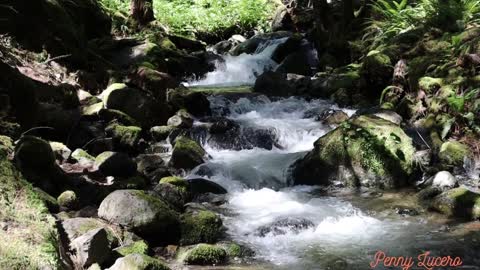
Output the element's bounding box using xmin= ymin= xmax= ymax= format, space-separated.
xmin=292 ymin=115 xmax=415 ymax=189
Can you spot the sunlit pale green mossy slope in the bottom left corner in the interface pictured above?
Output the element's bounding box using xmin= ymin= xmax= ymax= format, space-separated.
xmin=0 ymin=138 xmax=61 ymax=269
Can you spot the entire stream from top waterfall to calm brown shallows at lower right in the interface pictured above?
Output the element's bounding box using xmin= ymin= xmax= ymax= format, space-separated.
xmin=182 ymin=37 xmax=480 ymax=270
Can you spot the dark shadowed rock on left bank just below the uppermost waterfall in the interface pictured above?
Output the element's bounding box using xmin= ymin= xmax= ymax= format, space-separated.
xmin=167 ymin=87 xmax=211 ymax=117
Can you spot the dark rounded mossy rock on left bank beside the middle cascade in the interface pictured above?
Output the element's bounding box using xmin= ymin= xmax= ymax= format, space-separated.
xmin=169 ymin=136 xmax=207 ymax=170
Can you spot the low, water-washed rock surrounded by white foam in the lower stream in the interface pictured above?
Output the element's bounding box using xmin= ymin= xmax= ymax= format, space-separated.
xmin=255 ymin=218 xmax=315 ymax=237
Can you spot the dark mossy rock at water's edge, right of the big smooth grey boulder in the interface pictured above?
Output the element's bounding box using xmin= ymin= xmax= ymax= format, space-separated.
xmin=180 ymin=210 xmax=223 ymax=245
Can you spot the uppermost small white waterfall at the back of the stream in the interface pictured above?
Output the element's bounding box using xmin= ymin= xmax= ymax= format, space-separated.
xmin=188 ymin=38 xmax=287 ymax=86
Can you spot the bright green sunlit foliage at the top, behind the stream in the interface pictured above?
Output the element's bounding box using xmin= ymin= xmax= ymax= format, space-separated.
xmin=100 ymin=0 xmax=275 ymax=36
